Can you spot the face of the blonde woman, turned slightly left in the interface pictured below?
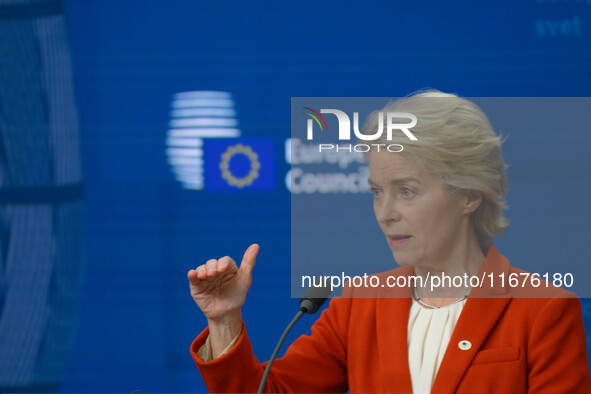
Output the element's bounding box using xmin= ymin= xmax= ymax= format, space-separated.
xmin=369 ymin=151 xmax=472 ymax=270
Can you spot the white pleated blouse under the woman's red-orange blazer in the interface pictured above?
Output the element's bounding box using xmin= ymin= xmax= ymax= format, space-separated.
xmin=407 ymin=298 xmax=466 ymax=394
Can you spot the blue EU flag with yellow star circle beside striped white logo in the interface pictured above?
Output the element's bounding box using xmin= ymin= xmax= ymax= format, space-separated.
xmin=204 ymin=138 xmax=275 ymax=191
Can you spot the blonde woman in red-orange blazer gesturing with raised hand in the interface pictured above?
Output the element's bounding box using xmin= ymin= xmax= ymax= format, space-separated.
xmin=188 ymin=91 xmax=591 ymax=394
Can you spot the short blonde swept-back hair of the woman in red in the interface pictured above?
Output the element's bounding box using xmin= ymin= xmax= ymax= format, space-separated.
xmin=362 ymin=90 xmax=510 ymax=251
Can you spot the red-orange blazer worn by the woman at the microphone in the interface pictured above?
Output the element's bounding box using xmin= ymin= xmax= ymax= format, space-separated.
xmin=191 ymin=245 xmax=591 ymax=394
